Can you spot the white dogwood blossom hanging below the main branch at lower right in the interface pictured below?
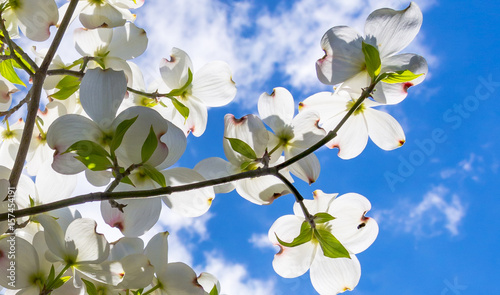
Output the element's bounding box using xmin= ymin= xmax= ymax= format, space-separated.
xmin=269 ymin=190 xmax=378 ymax=294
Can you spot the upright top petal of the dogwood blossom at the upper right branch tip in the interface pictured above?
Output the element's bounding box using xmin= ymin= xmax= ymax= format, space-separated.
xmin=365 ymin=2 xmax=423 ymax=58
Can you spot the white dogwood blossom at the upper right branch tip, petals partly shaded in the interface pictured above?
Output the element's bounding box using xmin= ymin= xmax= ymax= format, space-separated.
xmin=316 ymin=2 xmax=427 ymax=104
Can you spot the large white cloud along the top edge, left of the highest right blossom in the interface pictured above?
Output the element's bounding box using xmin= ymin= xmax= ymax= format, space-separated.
xmin=136 ymin=0 xmax=433 ymax=107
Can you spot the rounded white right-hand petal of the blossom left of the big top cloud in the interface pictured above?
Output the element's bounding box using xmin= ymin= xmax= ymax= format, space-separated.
xmin=192 ymin=61 xmax=236 ymax=107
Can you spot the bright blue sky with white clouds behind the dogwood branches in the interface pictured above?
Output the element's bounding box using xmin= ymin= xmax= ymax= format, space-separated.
xmin=4 ymin=0 xmax=500 ymax=295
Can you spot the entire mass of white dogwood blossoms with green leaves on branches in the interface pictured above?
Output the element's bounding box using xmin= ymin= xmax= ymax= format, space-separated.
xmin=0 ymin=0 xmax=427 ymax=295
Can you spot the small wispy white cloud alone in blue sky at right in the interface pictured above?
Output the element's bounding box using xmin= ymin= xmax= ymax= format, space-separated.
xmin=373 ymin=186 xmax=467 ymax=236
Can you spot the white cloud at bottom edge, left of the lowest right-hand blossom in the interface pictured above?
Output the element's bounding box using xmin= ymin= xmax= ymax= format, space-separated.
xmin=202 ymin=251 xmax=276 ymax=295
